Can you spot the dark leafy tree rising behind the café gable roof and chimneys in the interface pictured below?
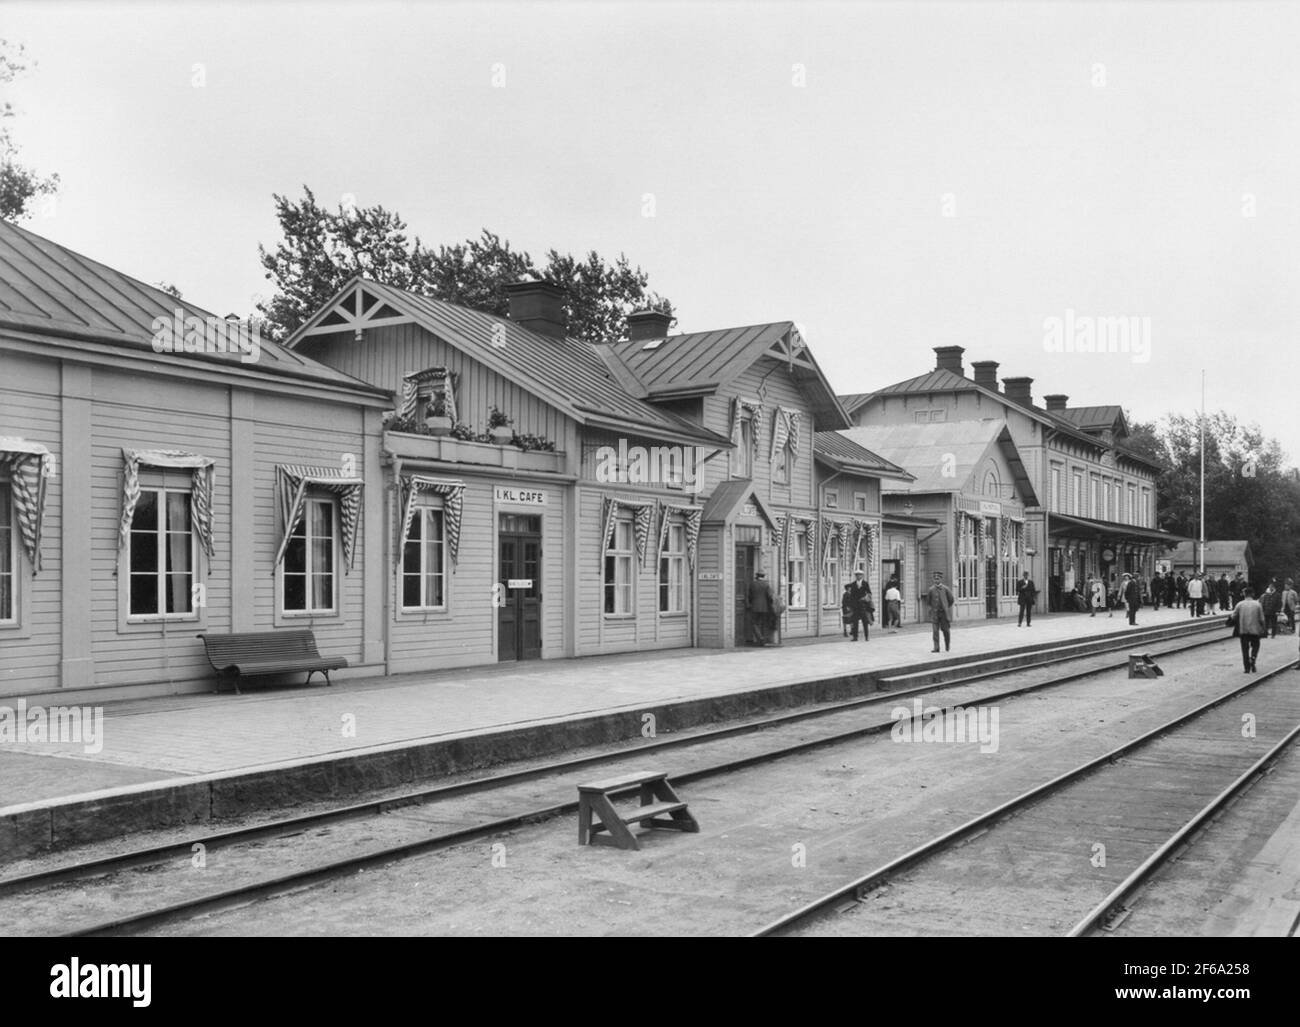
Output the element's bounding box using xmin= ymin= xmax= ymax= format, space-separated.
xmin=257 ymin=186 xmax=672 ymax=342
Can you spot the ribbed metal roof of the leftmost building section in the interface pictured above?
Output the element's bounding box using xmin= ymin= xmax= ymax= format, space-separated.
xmin=0 ymin=221 xmax=384 ymax=395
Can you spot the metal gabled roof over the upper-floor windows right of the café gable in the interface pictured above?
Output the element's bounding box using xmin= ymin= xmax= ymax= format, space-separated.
xmin=601 ymin=321 xmax=849 ymax=428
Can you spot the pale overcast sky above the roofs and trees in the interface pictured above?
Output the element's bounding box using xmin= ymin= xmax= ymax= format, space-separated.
xmin=0 ymin=0 xmax=1300 ymax=459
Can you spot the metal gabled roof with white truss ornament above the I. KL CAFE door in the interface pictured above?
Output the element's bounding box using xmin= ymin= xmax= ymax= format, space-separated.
xmin=285 ymin=277 xmax=732 ymax=449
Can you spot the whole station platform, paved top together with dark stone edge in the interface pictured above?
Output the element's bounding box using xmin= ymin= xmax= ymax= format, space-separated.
xmin=0 ymin=608 xmax=1242 ymax=861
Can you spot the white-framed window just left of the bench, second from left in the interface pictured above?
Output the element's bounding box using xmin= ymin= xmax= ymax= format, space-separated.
xmin=126 ymin=488 xmax=195 ymax=619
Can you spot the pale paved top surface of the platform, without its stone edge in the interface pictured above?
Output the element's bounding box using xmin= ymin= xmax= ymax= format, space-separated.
xmin=0 ymin=610 xmax=1248 ymax=807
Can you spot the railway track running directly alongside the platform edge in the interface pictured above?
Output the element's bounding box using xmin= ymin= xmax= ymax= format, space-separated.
xmin=0 ymin=618 xmax=1225 ymax=936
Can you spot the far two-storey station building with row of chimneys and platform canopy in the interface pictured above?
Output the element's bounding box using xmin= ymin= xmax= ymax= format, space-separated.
xmin=842 ymin=346 xmax=1182 ymax=611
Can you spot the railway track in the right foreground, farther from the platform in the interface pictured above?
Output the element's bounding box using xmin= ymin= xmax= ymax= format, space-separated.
xmin=754 ymin=662 xmax=1300 ymax=937
